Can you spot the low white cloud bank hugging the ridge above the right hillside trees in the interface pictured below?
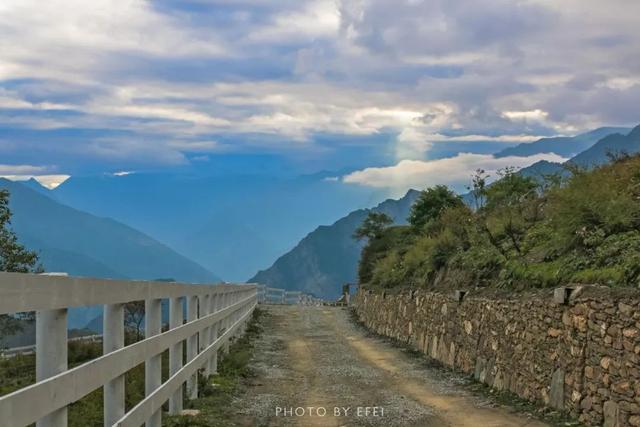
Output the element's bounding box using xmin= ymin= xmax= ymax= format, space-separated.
xmin=342 ymin=153 xmax=566 ymax=194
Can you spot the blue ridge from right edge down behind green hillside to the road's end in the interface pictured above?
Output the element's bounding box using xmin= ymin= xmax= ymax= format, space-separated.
xmin=251 ymin=126 xmax=640 ymax=298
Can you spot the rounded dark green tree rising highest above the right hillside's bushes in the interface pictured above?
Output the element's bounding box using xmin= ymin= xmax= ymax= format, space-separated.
xmin=407 ymin=185 xmax=463 ymax=230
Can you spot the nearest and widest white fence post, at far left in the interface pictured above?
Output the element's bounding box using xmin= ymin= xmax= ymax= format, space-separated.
xmin=33 ymin=309 xmax=68 ymax=427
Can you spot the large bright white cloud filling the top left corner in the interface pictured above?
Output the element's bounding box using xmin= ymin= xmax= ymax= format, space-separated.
xmin=0 ymin=0 xmax=225 ymax=77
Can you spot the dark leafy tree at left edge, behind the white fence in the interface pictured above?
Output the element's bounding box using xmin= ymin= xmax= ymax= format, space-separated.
xmin=0 ymin=189 xmax=42 ymax=336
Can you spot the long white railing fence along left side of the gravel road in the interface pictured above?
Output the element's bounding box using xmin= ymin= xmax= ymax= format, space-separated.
xmin=0 ymin=273 xmax=257 ymax=427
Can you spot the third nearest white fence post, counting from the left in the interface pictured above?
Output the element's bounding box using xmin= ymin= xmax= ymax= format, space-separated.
xmin=144 ymin=299 xmax=162 ymax=427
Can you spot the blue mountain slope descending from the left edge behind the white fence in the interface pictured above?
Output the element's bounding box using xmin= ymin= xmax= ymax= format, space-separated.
xmin=0 ymin=179 xmax=219 ymax=283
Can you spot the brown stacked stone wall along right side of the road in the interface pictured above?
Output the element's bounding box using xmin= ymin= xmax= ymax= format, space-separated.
xmin=354 ymin=286 xmax=640 ymax=427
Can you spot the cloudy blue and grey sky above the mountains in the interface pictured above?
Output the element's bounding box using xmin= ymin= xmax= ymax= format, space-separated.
xmin=0 ymin=0 xmax=640 ymax=191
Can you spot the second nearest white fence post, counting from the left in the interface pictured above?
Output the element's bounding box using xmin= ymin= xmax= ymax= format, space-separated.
xmin=102 ymin=304 xmax=125 ymax=426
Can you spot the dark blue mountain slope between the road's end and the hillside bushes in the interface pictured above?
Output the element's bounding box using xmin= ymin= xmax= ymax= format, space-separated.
xmin=250 ymin=190 xmax=419 ymax=298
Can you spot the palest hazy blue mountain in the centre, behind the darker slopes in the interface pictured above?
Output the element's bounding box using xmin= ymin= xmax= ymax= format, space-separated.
xmin=51 ymin=171 xmax=384 ymax=282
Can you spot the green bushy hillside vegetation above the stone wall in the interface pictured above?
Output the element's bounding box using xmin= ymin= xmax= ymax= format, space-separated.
xmin=354 ymin=156 xmax=640 ymax=289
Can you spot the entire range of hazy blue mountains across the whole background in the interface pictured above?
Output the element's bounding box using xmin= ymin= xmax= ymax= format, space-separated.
xmin=0 ymin=122 xmax=640 ymax=306
